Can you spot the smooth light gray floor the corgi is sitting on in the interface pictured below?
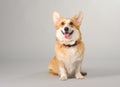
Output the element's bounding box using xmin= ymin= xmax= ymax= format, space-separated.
xmin=0 ymin=59 xmax=120 ymax=87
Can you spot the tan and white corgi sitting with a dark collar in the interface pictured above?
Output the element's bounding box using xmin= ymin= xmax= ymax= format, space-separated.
xmin=48 ymin=12 xmax=87 ymax=80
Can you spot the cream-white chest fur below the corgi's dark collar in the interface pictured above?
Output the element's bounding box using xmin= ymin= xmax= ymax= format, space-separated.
xmin=57 ymin=47 xmax=82 ymax=74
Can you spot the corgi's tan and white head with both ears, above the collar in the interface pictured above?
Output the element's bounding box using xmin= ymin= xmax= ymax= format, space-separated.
xmin=53 ymin=12 xmax=83 ymax=45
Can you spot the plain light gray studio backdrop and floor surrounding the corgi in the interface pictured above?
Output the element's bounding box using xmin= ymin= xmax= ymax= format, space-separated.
xmin=0 ymin=0 xmax=120 ymax=87
